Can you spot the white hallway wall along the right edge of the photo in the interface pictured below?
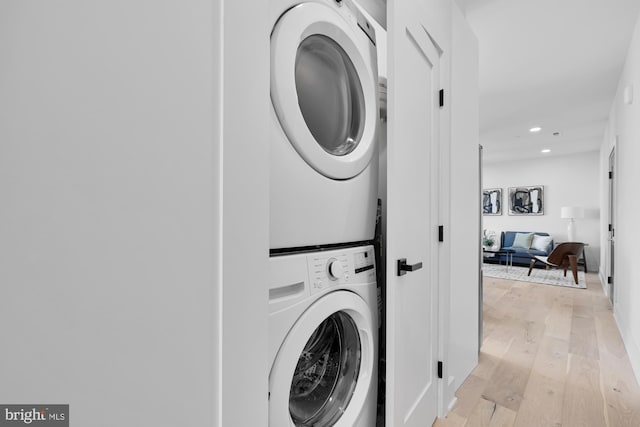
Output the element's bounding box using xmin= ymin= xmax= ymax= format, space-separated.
xmin=600 ymin=11 xmax=640 ymax=379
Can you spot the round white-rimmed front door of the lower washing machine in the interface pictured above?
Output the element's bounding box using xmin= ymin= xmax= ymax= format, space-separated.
xmin=269 ymin=291 xmax=375 ymax=427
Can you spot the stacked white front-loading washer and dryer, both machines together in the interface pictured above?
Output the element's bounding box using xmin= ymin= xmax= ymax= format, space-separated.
xmin=269 ymin=0 xmax=379 ymax=427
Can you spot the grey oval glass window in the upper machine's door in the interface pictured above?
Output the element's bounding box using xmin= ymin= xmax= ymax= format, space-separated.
xmin=295 ymin=34 xmax=364 ymax=156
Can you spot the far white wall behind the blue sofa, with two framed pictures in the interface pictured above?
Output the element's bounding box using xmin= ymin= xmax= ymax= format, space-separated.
xmin=483 ymin=151 xmax=606 ymax=272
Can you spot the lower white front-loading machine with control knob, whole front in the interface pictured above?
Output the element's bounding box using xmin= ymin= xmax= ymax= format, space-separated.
xmin=269 ymin=246 xmax=378 ymax=427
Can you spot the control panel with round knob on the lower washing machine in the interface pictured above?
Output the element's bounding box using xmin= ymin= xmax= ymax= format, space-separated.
xmin=307 ymin=246 xmax=375 ymax=294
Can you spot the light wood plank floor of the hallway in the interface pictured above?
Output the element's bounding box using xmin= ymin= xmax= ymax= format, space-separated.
xmin=433 ymin=273 xmax=640 ymax=427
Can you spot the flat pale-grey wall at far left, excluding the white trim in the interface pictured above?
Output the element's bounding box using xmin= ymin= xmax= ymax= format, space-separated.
xmin=0 ymin=0 xmax=214 ymax=426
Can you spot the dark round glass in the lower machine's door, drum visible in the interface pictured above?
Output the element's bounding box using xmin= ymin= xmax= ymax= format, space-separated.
xmin=289 ymin=312 xmax=361 ymax=427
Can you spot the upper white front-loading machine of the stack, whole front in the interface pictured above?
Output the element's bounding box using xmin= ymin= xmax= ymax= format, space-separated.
xmin=270 ymin=0 xmax=378 ymax=249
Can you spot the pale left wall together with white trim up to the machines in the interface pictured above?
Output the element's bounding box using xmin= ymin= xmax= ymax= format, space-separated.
xmin=0 ymin=0 xmax=268 ymax=427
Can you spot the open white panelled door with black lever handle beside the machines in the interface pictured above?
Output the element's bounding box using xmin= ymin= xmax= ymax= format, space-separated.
xmin=385 ymin=1 xmax=440 ymax=427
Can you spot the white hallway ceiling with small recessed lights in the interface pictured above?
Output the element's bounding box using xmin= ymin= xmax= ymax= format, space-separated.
xmin=456 ymin=0 xmax=640 ymax=162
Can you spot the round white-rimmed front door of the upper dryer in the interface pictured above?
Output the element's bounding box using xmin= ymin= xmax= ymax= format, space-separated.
xmin=271 ymin=3 xmax=377 ymax=179
